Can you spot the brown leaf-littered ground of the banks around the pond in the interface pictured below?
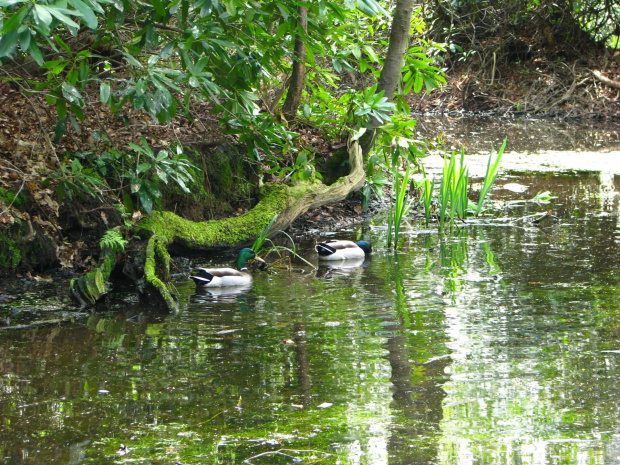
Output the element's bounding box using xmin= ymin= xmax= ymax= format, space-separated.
xmin=0 ymin=46 xmax=620 ymax=280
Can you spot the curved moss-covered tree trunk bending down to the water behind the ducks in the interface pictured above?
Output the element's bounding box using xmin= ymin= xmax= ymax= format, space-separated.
xmin=71 ymin=142 xmax=365 ymax=311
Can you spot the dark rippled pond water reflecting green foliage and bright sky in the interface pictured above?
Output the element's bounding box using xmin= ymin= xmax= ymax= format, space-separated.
xmin=0 ymin=120 xmax=620 ymax=465
